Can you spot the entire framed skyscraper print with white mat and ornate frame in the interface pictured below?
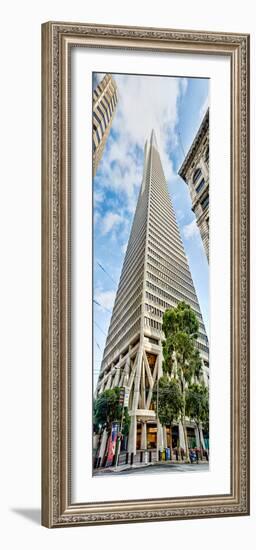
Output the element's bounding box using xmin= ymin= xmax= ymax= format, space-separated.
xmin=42 ymin=22 xmax=249 ymax=527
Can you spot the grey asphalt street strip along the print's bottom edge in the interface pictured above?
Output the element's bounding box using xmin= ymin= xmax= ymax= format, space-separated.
xmin=93 ymin=462 xmax=209 ymax=476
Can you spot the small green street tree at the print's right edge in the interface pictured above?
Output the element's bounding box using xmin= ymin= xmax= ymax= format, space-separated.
xmin=186 ymin=384 xmax=209 ymax=447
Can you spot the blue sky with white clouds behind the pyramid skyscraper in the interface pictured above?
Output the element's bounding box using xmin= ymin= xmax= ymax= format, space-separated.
xmin=93 ymin=74 xmax=209 ymax=388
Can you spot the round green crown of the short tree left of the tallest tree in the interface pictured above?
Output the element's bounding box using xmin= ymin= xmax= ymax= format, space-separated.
xmin=153 ymin=374 xmax=183 ymax=450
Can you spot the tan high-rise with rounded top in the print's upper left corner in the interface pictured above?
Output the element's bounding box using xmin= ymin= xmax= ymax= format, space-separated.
xmin=92 ymin=74 xmax=117 ymax=176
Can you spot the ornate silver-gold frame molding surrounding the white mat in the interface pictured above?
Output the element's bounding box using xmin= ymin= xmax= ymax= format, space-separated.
xmin=42 ymin=22 xmax=249 ymax=527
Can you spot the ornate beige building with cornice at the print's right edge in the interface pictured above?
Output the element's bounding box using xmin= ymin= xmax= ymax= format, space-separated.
xmin=179 ymin=109 xmax=209 ymax=261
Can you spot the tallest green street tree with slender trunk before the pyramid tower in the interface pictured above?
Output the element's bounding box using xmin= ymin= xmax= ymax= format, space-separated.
xmin=163 ymin=302 xmax=202 ymax=461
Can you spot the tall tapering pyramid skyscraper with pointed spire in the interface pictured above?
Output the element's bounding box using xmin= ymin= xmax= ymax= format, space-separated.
xmin=96 ymin=131 xmax=209 ymax=460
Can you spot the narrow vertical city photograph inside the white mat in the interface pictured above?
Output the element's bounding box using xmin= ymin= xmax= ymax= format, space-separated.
xmin=92 ymin=72 xmax=211 ymax=476
